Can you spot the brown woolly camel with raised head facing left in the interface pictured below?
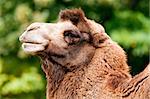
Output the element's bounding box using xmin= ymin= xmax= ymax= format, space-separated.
xmin=19 ymin=9 xmax=150 ymax=99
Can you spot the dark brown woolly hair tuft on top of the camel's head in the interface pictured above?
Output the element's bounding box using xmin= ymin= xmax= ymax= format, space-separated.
xmin=59 ymin=9 xmax=85 ymax=25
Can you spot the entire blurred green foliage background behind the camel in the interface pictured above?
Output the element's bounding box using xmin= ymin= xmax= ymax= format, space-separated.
xmin=0 ymin=0 xmax=150 ymax=99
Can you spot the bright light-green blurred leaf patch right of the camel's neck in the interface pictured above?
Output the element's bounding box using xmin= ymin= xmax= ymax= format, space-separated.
xmin=111 ymin=29 xmax=150 ymax=56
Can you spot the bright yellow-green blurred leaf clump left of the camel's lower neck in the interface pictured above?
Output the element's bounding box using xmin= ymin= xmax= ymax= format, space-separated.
xmin=1 ymin=68 xmax=44 ymax=95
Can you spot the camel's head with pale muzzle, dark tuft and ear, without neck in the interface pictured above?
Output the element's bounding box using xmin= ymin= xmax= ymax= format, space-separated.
xmin=19 ymin=9 xmax=109 ymax=68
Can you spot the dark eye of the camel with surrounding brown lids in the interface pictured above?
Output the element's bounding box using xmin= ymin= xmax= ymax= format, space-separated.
xmin=64 ymin=30 xmax=80 ymax=45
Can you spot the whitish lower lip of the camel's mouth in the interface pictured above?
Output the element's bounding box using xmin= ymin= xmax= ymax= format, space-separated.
xmin=22 ymin=43 xmax=45 ymax=54
